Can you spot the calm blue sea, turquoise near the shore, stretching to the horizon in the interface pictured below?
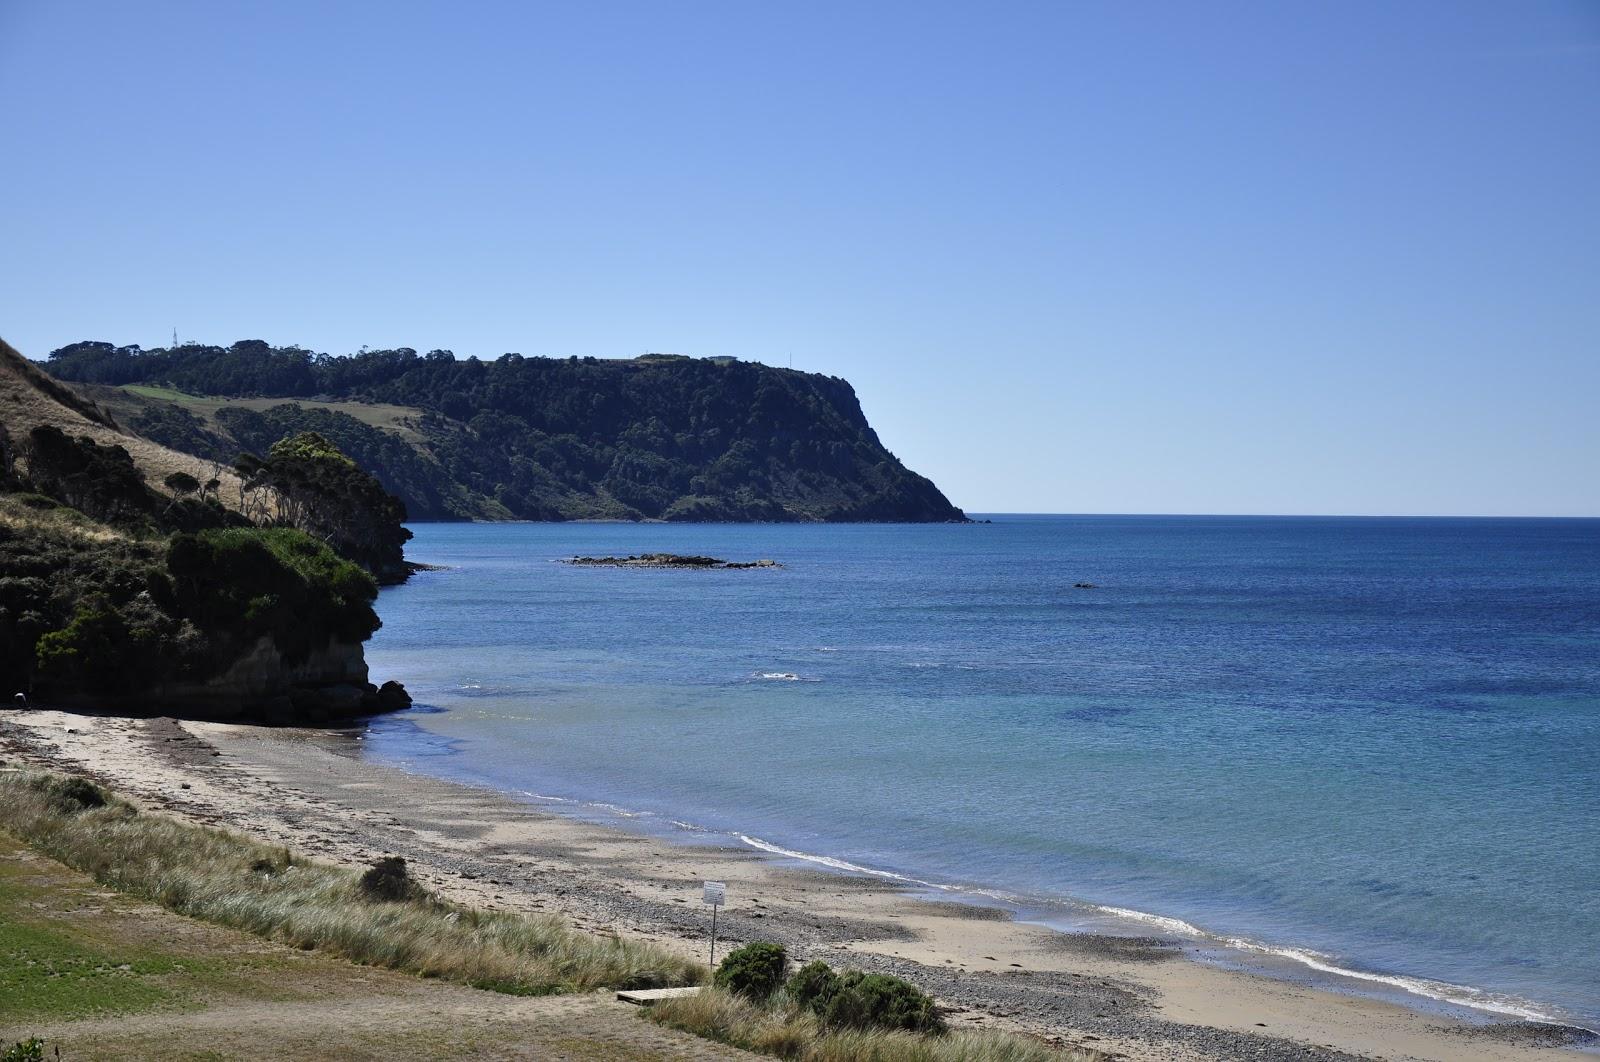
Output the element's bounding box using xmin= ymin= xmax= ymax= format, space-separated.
xmin=368 ymin=517 xmax=1600 ymax=1027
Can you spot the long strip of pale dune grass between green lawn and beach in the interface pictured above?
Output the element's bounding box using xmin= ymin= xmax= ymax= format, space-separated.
xmin=0 ymin=773 xmax=704 ymax=995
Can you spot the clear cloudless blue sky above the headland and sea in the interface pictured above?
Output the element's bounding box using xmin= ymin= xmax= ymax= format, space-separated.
xmin=0 ymin=0 xmax=1600 ymax=515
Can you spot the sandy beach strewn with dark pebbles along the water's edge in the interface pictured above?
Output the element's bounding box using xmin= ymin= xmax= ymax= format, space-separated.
xmin=0 ymin=710 xmax=1594 ymax=1062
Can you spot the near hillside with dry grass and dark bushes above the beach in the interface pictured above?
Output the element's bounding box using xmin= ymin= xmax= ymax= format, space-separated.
xmin=0 ymin=342 xmax=410 ymax=721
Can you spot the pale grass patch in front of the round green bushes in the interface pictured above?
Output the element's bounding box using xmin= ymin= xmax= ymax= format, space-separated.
xmin=646 ymin=987 xmax=1107 ymax=1062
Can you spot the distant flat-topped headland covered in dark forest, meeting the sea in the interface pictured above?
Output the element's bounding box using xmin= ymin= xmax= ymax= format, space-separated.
xmin=46 ymin=341 xmax=965 ymax=521
